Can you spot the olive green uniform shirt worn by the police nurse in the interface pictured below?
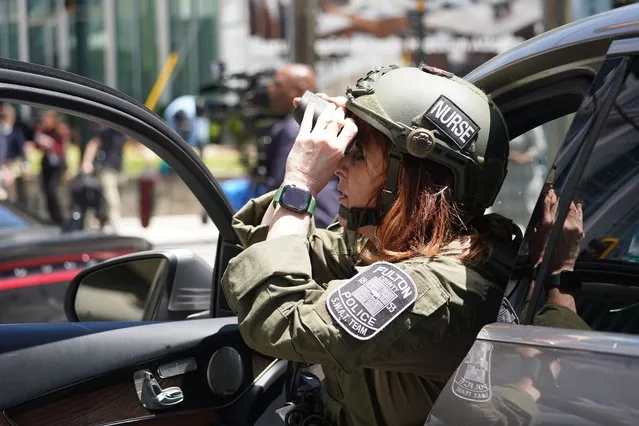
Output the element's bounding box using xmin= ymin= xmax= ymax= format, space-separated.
xmin=222 ymin=192 xmax=517 ymax=426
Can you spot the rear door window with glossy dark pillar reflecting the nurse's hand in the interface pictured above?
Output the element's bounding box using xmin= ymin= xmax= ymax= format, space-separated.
xmin=507 ymin=57 xmax=639 ymax=334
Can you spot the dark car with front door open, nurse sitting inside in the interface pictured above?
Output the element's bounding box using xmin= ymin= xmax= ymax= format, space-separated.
xmin=0 ymin=5 xmax=639 ymax=425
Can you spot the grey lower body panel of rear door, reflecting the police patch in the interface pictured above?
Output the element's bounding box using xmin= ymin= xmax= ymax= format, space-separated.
xmin=425 ymin=336 xmax=639 ymax=426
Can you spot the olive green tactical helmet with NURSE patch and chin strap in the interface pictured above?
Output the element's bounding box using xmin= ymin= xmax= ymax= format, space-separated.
xmin=340 ymin=64 xmax=509 ymax=228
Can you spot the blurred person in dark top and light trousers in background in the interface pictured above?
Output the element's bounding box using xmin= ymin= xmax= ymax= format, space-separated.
xmin=81 ymin=125 xmax=126 ymax=230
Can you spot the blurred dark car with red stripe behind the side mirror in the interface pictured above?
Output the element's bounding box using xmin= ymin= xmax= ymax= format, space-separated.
xmin=0 ymin=201 xmax=152 ymax=324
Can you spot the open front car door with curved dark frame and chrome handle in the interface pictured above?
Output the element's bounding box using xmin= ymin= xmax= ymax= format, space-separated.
xmin=0 ymin=59 xmax=285 ymax=426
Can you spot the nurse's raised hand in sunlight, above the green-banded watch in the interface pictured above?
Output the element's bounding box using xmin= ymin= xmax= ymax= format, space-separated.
xmin=284 ymin=95 xmax=357 ymax=196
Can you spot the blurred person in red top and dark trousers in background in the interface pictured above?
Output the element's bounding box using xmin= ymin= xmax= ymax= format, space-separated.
xmin=34 ymin=110 xmax=71 ymax=225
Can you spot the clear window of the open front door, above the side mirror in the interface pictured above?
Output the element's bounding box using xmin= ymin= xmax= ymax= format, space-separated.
xmin=0 ymin=104 xmax=217 ymax=323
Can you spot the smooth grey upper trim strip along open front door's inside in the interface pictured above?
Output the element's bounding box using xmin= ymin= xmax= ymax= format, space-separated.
xmin=0 ymin=318 xmax=235 ymax=409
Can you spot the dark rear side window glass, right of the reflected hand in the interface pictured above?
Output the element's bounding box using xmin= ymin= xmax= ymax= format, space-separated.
xmin=575 ymin=61 xmax=639 ymax=333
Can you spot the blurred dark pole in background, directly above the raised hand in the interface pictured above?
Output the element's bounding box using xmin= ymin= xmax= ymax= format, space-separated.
xmin=289 ymin=0 xmax=318 ymax=67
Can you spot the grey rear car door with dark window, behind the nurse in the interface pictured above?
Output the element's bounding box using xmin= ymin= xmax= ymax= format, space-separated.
xmin=426 ymin=25 xmax=639 ymax=425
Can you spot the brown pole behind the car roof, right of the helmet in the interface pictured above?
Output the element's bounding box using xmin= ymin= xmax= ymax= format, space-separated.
xmin=543 ymin=0 xmax=574 ymax=167
